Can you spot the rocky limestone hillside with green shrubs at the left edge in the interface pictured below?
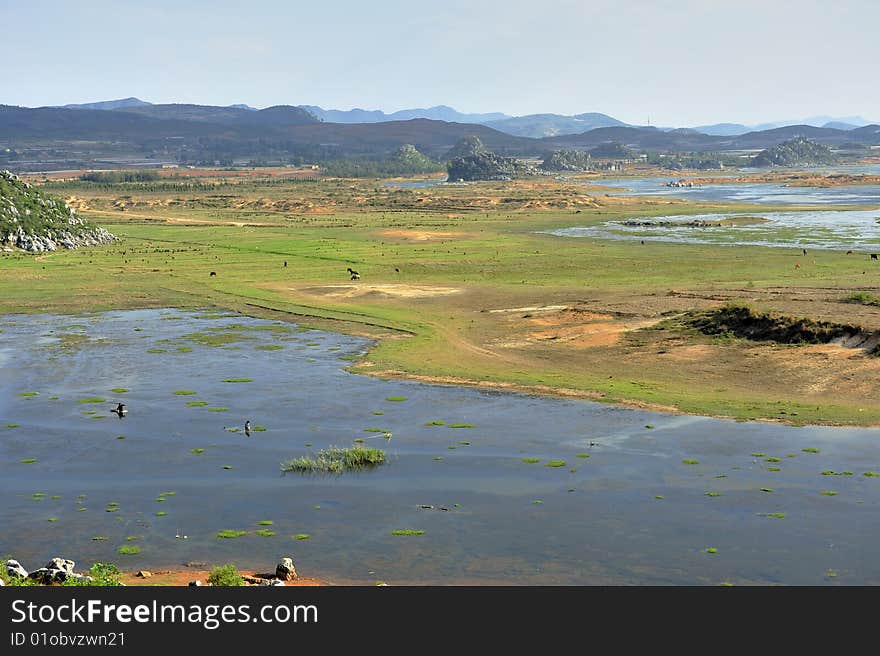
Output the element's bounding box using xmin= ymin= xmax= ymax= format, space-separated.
xmin=0 ymin=171 xmax=116 ymax=253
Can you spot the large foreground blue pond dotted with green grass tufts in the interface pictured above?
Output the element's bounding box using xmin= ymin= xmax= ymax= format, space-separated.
xmin=0 ymin=309 xmax=880 ymax=585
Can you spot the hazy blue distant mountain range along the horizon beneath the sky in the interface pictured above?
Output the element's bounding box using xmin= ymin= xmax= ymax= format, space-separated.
xmin=0 ymin=98 xmax=880 ymax=170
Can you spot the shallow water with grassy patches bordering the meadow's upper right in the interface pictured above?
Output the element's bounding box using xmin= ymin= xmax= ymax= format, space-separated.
xmin=548 ymin=210 xmax=880 ymax=252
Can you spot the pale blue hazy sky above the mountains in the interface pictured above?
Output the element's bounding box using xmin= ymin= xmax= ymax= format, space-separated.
xmin=0 ymin=0 xmax=880 ymax=126
